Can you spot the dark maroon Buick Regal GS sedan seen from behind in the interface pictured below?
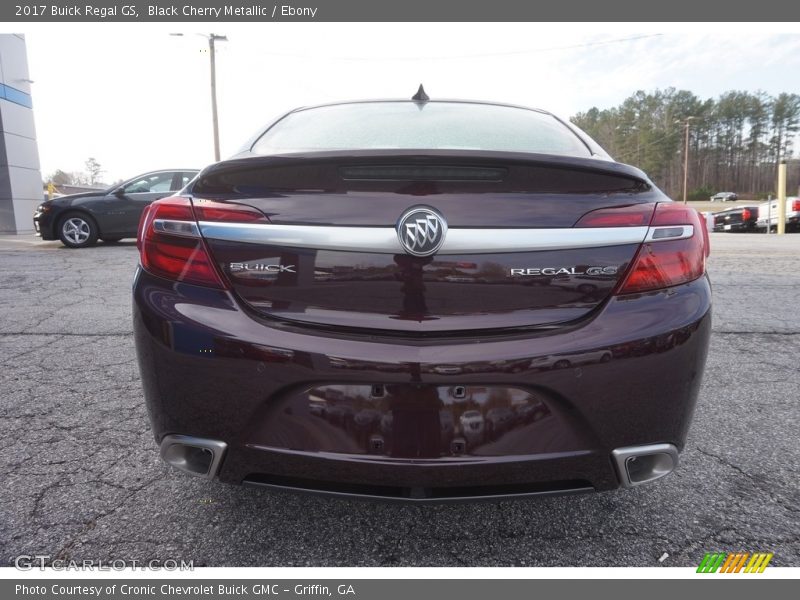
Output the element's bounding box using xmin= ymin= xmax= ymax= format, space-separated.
xmin=133 ymin=93 xmax=711 ymax=501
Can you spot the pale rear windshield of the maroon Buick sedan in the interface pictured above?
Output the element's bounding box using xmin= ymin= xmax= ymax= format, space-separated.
xmin=252 ymin=102 xmax=591 ymax=157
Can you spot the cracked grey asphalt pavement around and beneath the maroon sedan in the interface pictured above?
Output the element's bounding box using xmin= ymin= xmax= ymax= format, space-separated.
xmin=0 ymin=234 xmax=800 ymax=567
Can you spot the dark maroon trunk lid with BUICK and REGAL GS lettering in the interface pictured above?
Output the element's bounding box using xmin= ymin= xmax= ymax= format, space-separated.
xmin=192 ymin=151 xmax=668 ymax=335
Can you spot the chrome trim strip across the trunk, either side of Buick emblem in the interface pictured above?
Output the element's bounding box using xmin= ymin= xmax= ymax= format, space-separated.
xmin=200 ymin=221 xmax=648 ymax=255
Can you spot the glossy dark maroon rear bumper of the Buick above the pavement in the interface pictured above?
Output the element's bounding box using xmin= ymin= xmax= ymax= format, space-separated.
xmin=133 ymin=270 xmax=711 ymax=501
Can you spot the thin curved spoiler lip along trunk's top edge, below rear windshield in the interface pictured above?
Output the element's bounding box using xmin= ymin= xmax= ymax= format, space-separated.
xmin=195 ymin=149 xmax=656 ymax=188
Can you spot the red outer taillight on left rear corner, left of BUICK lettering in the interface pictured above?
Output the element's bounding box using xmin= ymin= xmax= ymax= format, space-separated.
xmin=137 ymin=196 xmax=225 ymax=289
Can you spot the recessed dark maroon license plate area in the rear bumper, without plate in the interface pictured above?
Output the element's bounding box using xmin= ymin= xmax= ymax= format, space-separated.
xmin=245 ymin=384 xmax=592 ymax=459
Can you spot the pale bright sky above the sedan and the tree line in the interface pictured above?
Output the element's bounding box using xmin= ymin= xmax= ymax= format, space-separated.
xmin=9 ymin=23 xmax=800 ymax=183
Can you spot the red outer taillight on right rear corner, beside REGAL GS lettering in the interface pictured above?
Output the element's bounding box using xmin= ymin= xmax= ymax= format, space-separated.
xmin=617 ymin=203 xmax=710 ymax=294
